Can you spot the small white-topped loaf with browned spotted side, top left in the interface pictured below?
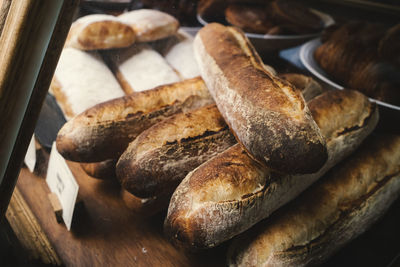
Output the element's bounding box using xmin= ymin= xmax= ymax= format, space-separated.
xmin=65 ymin=14 xmax=135 ymax=50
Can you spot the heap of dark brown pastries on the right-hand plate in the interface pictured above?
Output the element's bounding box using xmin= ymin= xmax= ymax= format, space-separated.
xmin=314 ymin=22 xmax=400 ymax=105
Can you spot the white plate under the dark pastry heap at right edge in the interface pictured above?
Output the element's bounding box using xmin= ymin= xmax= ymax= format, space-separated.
xmin=300 ymin=38 xmax=400 ymax=111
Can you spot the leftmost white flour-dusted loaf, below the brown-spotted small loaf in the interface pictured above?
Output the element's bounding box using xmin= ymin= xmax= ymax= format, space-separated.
xmin=50 ymin=48 xmax=125 ymax=120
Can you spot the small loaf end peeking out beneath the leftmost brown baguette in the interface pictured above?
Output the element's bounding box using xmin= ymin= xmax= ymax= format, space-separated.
xmin=81 ymin=159 xmax=117 ymax=180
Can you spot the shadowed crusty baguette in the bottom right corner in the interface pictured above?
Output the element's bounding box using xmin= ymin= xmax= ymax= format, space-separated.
xmin=228 ymin=135 xmax=400 ymax=266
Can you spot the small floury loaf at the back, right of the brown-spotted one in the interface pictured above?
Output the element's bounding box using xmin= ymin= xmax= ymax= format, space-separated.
xmin=118 ymin=9 xmax=179 ymax=42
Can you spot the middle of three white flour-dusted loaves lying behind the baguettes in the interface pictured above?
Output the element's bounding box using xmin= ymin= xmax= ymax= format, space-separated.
xmin=105 ymin=44 xmax=181 ymax=94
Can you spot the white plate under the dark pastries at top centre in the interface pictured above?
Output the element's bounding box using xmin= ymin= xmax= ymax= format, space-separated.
xmin=197 ymin=9 xmax=335 ymax=52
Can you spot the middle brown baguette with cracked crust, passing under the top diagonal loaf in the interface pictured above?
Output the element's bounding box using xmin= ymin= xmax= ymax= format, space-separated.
xmin=117 ymin=73 xmax=322 ymax=200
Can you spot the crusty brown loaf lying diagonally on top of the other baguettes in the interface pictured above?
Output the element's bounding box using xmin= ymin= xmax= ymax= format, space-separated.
xmin=194 ymin=23 xmax=327 ymax=173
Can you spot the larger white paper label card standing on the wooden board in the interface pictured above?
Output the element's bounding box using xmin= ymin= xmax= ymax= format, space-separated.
xmin=46 ymin=143 xmax=79 ymax=230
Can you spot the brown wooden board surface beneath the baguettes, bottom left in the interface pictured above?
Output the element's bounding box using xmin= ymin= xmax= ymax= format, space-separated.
xmin=17 ymin=153 xmax=226 ymax=267
